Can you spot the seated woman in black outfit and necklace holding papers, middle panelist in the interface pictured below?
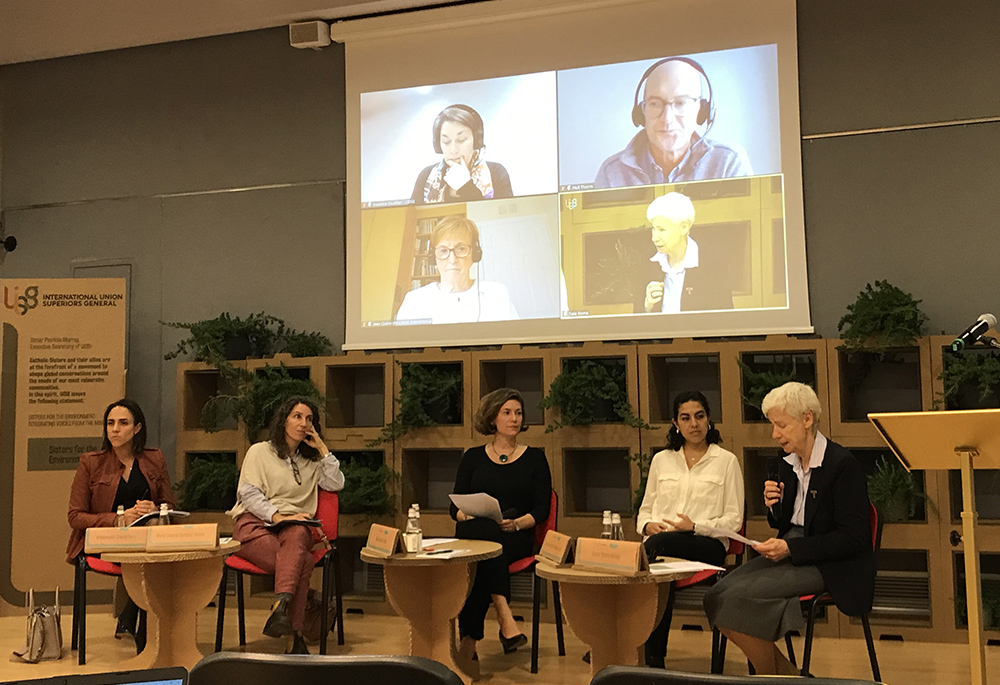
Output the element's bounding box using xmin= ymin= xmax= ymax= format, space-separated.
xmin=451 ymin=388 xmax=552 ymax=670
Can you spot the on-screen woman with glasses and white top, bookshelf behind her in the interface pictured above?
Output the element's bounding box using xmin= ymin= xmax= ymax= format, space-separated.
xmin=396 ymin=215 xmax=518 ymax=324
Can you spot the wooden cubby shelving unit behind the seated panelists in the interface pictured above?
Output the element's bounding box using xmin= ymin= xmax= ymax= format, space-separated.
xmin=177 ymin=336 xmax=1000 ymax=643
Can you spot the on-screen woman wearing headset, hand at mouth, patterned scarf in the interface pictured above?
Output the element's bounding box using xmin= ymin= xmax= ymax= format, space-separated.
xmin=412 ymin=105 xmax=514 ymax=205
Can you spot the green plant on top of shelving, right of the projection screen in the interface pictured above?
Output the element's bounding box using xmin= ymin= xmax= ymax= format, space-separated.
xmin=837 ymin=281 xmax=927 ymax=356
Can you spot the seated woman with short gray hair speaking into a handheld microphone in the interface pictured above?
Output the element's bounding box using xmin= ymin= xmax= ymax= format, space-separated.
xmin=705 ymin=383 xmax=875 ymax=675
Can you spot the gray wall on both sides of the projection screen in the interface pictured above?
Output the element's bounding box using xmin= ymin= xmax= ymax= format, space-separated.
xmin=0 ymin=0 xmax=1000 ymax=464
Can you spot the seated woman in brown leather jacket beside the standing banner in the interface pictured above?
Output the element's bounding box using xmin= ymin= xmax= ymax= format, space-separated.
xmin=66 ymin=398 xmax=174 ymax=637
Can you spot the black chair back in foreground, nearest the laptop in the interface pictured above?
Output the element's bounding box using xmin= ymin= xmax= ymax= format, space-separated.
xmin=188 ymin=652 xmax=463 ymax=685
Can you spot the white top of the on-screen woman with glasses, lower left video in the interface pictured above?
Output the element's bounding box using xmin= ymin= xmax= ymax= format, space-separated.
xmin=396 ymin=280 xmax=519 ymax=324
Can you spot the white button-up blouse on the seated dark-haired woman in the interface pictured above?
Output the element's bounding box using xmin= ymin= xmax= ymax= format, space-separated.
xmin=636 ymin=445 xmax=743 ymax=544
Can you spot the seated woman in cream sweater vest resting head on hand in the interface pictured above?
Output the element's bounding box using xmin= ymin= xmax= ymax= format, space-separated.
xmin=229 ymin=397 xmax=344 ymax=654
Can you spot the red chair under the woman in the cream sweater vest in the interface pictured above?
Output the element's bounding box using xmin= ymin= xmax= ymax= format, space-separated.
xmin=215 ymin=488 xmax=344 ymax=654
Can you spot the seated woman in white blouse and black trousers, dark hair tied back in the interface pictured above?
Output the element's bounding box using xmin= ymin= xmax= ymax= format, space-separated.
xmin=636 ymin=391 xmax=743 ymax=668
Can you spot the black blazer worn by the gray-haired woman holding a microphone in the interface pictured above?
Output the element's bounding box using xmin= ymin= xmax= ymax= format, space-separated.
xmin=768 ymin=440 xmax=875 ymax=616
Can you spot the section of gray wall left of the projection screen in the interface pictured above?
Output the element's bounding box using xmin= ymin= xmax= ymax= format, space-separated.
xmin=0 ymin=29 xmax=345 ymax=470
